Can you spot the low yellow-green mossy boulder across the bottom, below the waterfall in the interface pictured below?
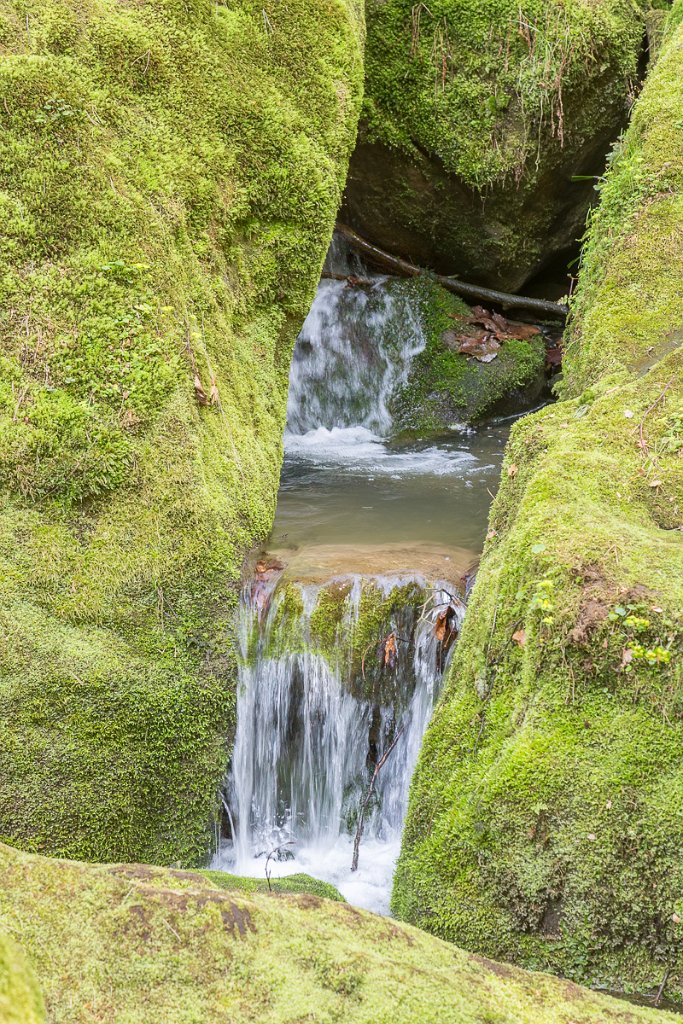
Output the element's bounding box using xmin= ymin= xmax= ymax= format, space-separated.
xmin=0 ymin=847 xmax=677 ymax=1024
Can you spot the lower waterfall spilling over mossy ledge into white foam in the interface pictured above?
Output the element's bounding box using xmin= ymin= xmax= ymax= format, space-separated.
xmin=217 ymin=578 xmax=462 ymax=912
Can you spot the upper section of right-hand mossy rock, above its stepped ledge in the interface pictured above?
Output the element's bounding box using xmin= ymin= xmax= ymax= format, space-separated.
xmin=565 ymin=7 xmax=683 ymax=395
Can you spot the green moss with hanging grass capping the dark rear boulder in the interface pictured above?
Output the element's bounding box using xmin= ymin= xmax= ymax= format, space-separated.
xmin=364 ymin=0 xmax=649 ymax=190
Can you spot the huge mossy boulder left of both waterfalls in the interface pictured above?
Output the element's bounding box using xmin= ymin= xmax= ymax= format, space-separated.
xmin=0 ymin=0 xmax=362 ymax=863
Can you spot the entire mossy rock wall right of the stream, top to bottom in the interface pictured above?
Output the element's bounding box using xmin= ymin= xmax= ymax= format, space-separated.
xmin=393 ymin=0 xmax=683 ymax=997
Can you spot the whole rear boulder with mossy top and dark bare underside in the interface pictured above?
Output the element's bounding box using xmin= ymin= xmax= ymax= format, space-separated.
xmin=345 ymin=0 xmax=650 ymax=291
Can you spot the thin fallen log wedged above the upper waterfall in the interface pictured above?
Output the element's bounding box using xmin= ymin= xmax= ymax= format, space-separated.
xmin=333 ymin=222 xmax=568 ymax=319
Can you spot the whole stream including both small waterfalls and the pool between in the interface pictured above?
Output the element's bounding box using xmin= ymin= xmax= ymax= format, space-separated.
xmin=213 ymin=239 xmax=509 ymax=913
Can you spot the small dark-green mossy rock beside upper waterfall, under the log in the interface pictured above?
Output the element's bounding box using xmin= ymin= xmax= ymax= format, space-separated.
xmin=389 ymin=275 xmax=546 ymax=437
